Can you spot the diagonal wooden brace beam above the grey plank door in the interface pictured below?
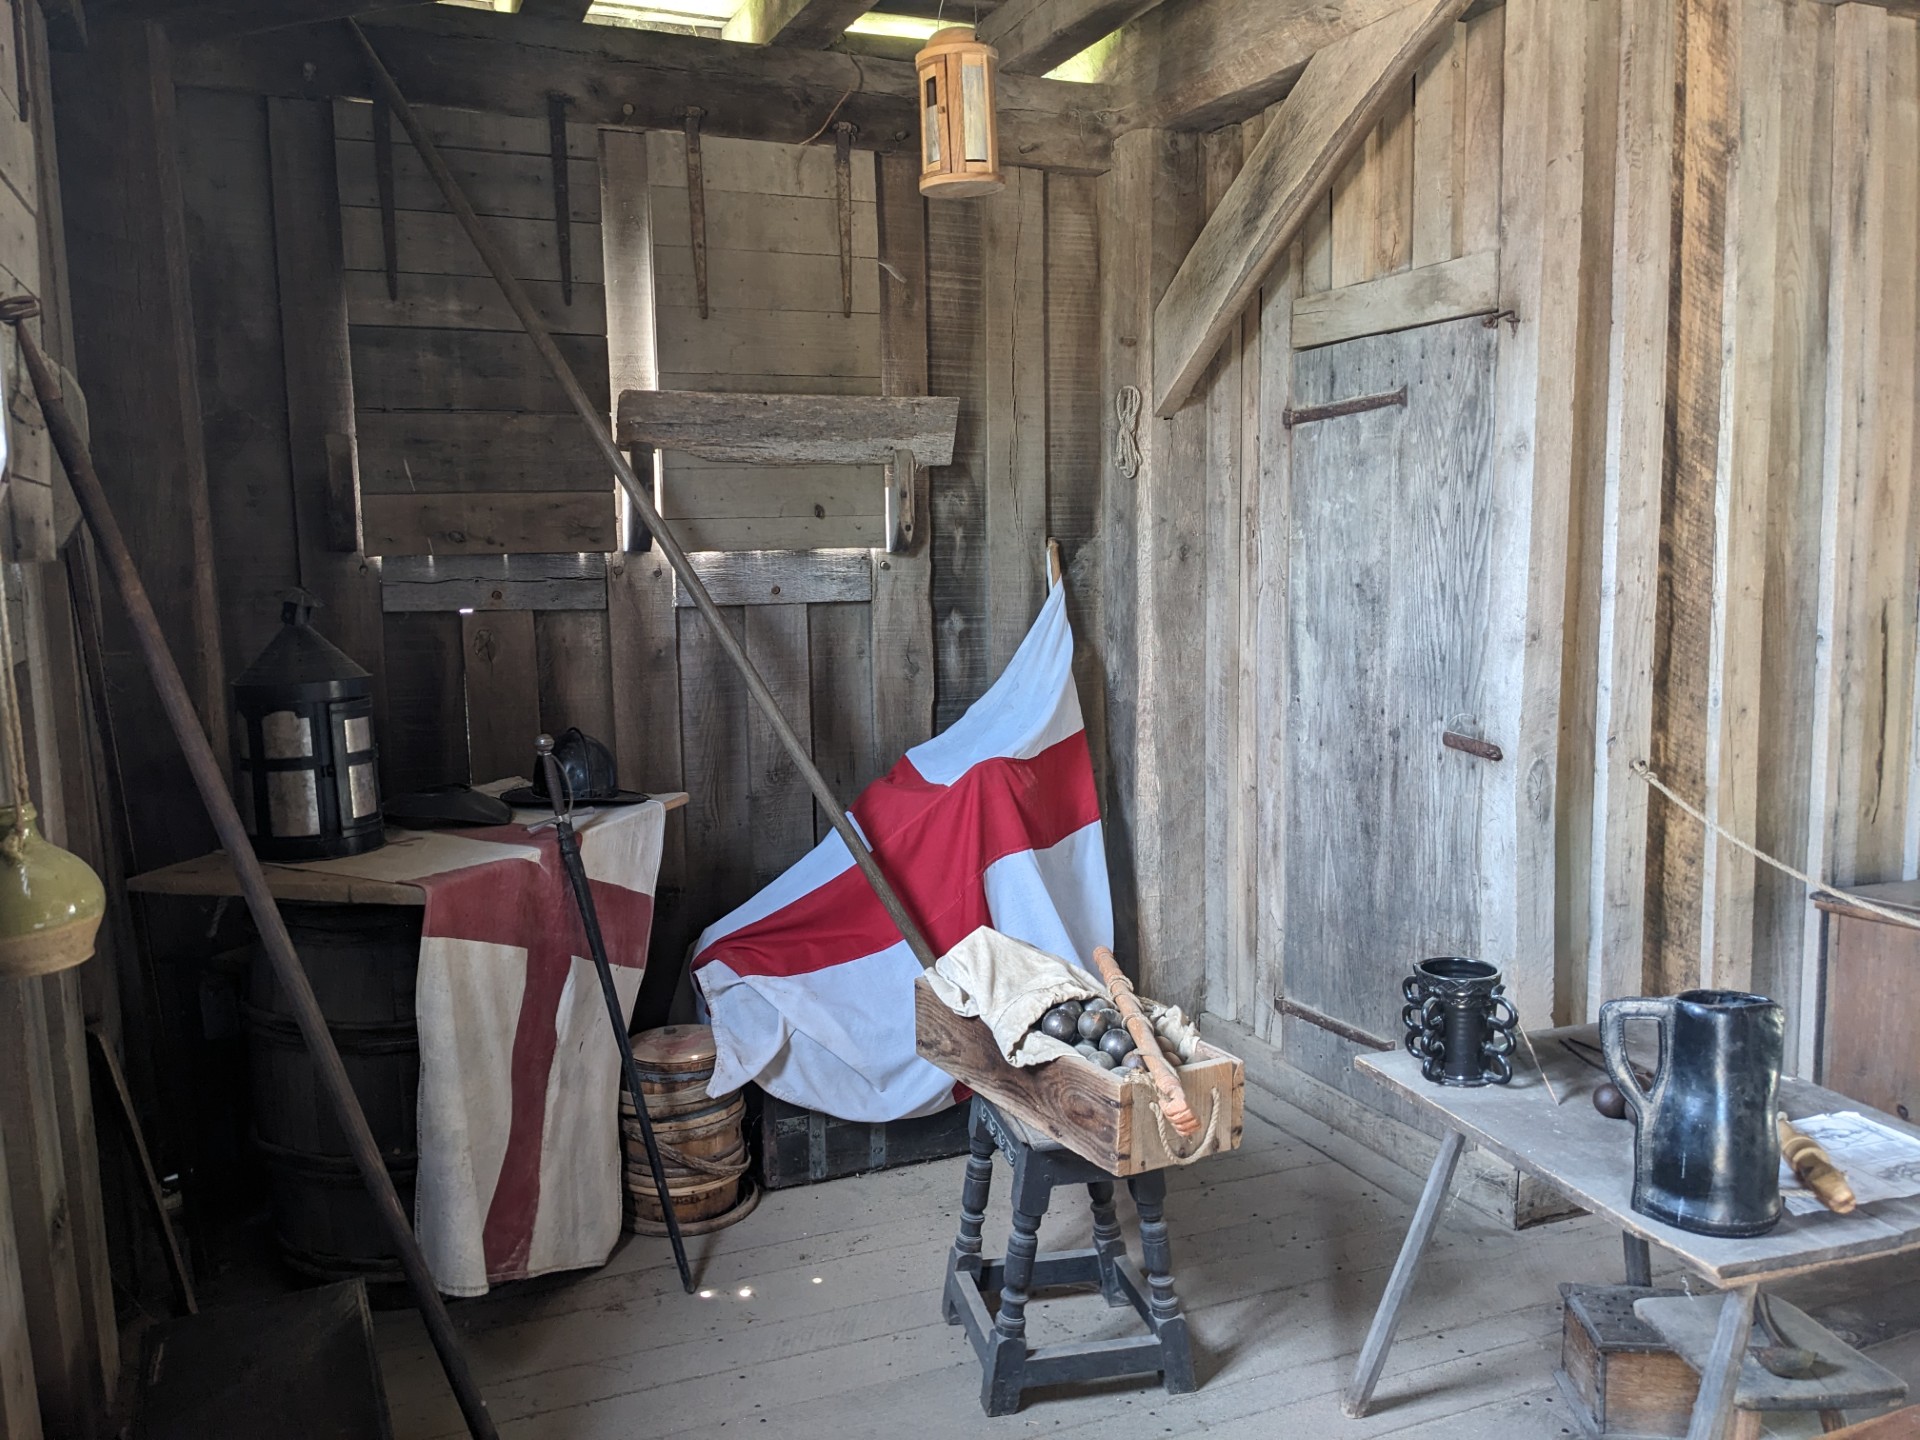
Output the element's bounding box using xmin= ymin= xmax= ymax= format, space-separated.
xmin=1154 ymin=0 xmax=1467 ymax=415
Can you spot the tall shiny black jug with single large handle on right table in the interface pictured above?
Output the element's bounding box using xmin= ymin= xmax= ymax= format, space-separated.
xmin=1599 ymin=991 xmax=1786 ymax=1236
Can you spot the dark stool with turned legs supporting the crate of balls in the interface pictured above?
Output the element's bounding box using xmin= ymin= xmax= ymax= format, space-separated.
xmin=941 ymin=1096 xmax=1194 ymax=1415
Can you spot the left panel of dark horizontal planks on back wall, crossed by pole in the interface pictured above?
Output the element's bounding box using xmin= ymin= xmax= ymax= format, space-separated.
xmin=334 ymin=100 xmax=614 ymax=555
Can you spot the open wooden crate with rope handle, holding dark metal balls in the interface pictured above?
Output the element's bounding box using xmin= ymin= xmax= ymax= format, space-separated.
xmin=914 ymin=975 xmax=1246 ymax=1175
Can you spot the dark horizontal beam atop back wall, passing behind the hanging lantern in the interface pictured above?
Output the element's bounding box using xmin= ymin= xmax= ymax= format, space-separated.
xmin=175 ymin=6 xmax=1114 ymax=175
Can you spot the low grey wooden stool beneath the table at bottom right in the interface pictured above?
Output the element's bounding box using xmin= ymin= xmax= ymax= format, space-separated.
xmin=1634 ymin=1294 xmax=1907 ymax=1440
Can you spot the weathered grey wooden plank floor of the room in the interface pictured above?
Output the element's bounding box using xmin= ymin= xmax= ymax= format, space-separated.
xmin=378 ymin=1091 xmax=1920 ymax=1440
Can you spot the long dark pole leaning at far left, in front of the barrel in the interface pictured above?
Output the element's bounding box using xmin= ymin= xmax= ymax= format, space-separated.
xmin=0 ymin=296 xmax=499 ymax=1440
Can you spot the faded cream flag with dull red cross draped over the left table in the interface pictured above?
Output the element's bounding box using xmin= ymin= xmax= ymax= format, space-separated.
xmin=407 ymin=801 xmax=664 ymax=1296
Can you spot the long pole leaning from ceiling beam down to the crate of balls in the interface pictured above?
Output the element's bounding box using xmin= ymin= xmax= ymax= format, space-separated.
xmin=344 ymin=19 xmax=937 ymax=968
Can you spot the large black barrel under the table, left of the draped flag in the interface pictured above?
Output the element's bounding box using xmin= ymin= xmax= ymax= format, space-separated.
xmin=246 ymin=904 xmax=420 ymax=1283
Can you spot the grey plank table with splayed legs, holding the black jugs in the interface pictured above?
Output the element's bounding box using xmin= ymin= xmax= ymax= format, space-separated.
xmin=1344 ymin=1025 xmax=1920 ymax=1440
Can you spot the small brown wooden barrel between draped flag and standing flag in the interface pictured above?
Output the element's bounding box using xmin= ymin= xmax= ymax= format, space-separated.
xmin=620 ymin=1025 xmax=747 ymax=1233
